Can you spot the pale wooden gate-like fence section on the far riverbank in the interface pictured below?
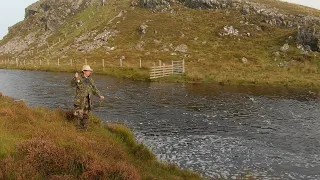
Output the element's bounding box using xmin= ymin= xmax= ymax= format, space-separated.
xmin=150 ymin=60 xmax=185 ymax=79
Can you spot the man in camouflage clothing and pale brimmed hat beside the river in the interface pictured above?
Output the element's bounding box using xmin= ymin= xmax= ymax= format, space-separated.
xmin=71 ymin=65 xmax=104 ymax=130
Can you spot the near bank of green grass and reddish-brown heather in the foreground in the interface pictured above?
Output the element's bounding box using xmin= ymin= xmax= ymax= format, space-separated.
xmin=0 ymin=95 xmax=202 ymax=180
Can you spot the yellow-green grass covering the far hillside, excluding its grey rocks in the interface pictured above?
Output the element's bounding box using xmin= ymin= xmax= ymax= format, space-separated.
xmin=0 ymin=0 xmax=320 ymax=87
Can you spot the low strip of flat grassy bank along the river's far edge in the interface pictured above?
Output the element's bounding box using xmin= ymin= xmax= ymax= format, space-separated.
xmin=0 ymin=57 xmax=320 ymax=88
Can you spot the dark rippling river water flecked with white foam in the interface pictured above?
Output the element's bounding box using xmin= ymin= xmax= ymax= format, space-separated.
xmin=0 ymin=70 xmax=320 ymax=179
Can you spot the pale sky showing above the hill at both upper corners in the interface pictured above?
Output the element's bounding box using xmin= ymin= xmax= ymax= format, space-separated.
xmin=0 ymin=0 xmax=320 ymax=39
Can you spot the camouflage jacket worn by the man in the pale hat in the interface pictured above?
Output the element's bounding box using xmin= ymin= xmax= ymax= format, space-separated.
xmin=71 ymin=74 xmax=101 ymax=109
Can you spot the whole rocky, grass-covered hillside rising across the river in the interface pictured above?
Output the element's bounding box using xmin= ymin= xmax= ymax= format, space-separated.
xmin=0 ymin=0 xmax=320 ymax=87
